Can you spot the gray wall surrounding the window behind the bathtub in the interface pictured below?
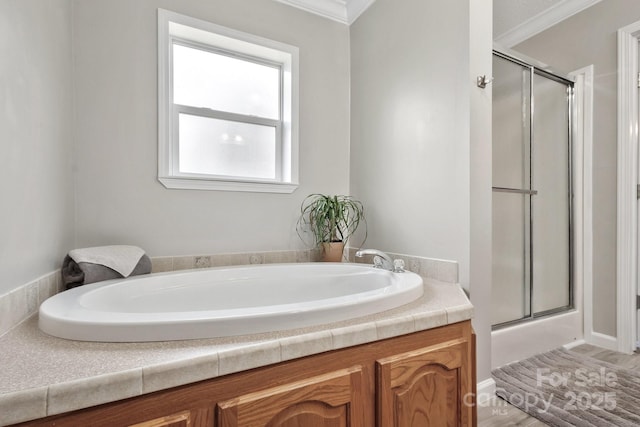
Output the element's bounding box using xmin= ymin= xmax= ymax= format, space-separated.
xmin=73 ymin=0 xmax=349 ymax=256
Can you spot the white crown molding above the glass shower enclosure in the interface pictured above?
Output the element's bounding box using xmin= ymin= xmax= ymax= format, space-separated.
xmin=494 ymin=0 xmax=602 ymax=48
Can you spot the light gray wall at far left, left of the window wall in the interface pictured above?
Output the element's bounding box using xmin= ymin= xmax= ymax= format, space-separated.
xmin=0 ymin=0 xmax=74 ymax=295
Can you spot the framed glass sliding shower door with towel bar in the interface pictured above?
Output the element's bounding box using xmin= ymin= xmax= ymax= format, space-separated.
xmin=492 ymin=52 xmax=573 ymax=328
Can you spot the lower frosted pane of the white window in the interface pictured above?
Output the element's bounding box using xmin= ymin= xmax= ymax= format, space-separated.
xmin=179 ymin=114 xmax=276 ymax=179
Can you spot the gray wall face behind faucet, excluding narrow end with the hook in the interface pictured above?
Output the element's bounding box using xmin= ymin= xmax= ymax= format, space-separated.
xmin=351 ymin=0 xmax=470 ymax=286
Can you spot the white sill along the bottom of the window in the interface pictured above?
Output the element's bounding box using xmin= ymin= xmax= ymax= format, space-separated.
xmin=158 ymin=176 xmax=298 ymax=194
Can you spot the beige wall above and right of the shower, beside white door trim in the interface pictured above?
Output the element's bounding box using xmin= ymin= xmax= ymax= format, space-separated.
xmin=514 ymin=0 xmax=640 ymax=336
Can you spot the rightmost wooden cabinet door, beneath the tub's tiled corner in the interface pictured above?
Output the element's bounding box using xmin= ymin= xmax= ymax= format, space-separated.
xmin=376 ymin=340 xmax=472 ymax=427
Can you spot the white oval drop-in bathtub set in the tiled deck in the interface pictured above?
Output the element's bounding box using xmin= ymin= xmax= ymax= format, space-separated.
xmin=39 ymin=263 xmax=423 ymax=342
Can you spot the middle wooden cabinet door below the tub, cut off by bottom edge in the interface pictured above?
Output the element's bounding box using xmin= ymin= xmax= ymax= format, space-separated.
xmin=217 ymin=366 xmax=365 ymax=427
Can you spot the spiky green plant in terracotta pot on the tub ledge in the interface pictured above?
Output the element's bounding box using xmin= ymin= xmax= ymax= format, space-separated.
xmin=296 ymin=194 xmax=367 ymax=262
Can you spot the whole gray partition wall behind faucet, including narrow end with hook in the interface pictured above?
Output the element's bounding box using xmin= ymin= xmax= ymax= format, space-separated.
xmin=351 ymin=0 xmax=493 ymax=381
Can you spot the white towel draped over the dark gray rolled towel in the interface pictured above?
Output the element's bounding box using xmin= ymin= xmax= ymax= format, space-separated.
xmin=69 ymin=245 xmax=144 ymax=277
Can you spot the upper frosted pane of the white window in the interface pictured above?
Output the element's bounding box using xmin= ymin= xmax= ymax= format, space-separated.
xmin=173 ymin=44 xmax=280 ymax=120
